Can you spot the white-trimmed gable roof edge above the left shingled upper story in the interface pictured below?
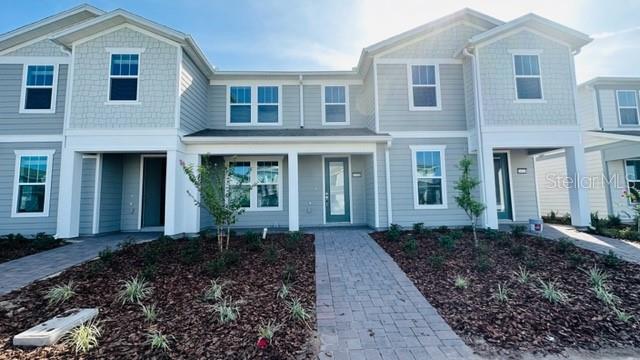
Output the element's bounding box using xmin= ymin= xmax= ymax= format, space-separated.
xmin=52 ymin=9 xmax=214 ymax=76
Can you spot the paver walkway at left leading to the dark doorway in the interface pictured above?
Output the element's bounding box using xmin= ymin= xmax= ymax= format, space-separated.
xmin=0 ymin=233 xmax=159 ymax=295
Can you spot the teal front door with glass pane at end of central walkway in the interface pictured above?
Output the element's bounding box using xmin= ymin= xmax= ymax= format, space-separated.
xmin=324 ymin=157 xmax=351 ymax=223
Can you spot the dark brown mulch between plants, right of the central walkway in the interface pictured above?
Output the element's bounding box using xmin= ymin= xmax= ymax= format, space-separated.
xmin=371 ymin=231 xmax=640 ymax=357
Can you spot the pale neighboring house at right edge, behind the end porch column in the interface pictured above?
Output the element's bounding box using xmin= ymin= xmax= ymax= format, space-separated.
xmin=536 ymin=77 xmax=640 ymax=221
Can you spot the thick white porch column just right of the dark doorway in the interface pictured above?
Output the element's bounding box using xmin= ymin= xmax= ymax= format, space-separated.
xmin=164 ymin=150 xmax=200 ymax=235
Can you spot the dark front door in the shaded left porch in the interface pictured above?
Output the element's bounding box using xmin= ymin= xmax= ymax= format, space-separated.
xmin=141 ymin=156 xmax=167 ymax=227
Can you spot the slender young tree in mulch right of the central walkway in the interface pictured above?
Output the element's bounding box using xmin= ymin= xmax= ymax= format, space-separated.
xmin=455 ymin=156 xmax=486 ymax=247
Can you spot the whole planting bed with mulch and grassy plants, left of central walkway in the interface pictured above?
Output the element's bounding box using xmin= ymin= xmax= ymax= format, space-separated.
xmin=0 ymin=232 xmax=316 ymax=359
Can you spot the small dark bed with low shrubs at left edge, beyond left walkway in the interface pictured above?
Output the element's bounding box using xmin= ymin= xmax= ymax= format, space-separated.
xmin=0 ymin=233 xmax=67 ymax=263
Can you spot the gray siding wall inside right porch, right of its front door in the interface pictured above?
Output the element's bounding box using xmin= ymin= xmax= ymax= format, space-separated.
xmin=509 ymin=149 xmax=538 ymax=221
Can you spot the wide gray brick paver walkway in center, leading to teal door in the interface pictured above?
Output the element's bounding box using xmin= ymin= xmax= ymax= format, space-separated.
xmin=314 ymin=229 xmax=474 ymax=360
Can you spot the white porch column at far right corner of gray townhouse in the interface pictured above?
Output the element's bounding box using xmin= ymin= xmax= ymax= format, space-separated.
xmin=565 ymin=144 xmax=591 ymax=227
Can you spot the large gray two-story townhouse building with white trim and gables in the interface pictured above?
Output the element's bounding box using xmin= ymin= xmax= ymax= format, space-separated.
xmin=0 ymin=6 xmax=590 ymax=237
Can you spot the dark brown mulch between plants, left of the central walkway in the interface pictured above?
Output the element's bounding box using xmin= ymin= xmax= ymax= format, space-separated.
xmin=0 ymin=234 xmax=315 ymax=359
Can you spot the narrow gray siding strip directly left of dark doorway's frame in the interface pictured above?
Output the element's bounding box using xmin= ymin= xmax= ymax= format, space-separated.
xmin=120 ymin=154 xmax=141 ymax=231
